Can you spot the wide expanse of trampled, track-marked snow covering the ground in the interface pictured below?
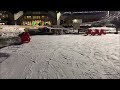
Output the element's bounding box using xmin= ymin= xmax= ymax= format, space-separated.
xmin=0 ymin=34 xmax=120 ymax=79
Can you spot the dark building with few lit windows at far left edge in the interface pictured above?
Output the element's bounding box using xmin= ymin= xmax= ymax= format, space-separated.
xmin=0 ymin=11 xmax=14 ymax=25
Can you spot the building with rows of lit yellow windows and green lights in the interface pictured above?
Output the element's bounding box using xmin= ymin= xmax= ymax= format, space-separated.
xmin=17 ymin=11 xmax=57 ymax=26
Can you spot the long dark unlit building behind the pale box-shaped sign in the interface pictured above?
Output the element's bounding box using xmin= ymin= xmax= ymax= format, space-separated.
xmin=60 ymin=11 xmax=106 ymax=24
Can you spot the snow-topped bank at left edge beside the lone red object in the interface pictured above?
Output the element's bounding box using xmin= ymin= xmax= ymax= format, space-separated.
xmin=0 ymin=26 xmax=25 ymax=48
